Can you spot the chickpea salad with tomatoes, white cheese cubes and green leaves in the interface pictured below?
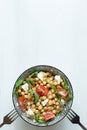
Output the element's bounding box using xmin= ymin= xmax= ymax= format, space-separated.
xmin=15 ymin=71 xmax=73 ymax=123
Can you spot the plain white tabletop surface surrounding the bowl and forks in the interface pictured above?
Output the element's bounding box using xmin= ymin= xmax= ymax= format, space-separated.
xmin=0 ymin=0 xmax=87 ymax=130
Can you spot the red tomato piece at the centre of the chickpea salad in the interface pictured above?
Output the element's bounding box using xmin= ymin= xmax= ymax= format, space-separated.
xmin=36 ymin=85 xmax=48 ymax=96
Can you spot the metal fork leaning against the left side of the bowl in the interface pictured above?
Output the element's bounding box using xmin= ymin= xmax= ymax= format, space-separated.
xmin=0 ymin=109 xmax=18 ymax=127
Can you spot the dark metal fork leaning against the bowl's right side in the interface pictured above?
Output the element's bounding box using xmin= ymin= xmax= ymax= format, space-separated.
xmin=67 ymin=109 xmax=87 ymax=130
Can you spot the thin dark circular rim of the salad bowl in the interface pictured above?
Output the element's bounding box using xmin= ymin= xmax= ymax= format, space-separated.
xmin=12 ymin=65 xmax=74 ymax=127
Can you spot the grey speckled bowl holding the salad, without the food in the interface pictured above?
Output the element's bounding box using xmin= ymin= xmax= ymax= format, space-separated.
xmin=12 ymin=65 xmax=73 ymax=127
